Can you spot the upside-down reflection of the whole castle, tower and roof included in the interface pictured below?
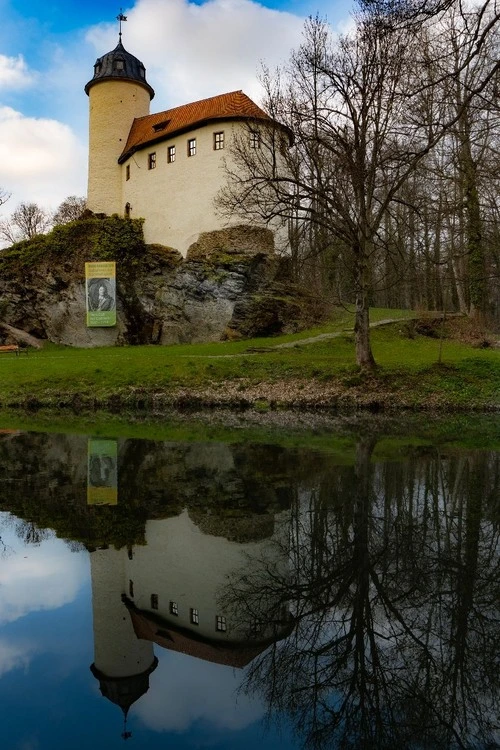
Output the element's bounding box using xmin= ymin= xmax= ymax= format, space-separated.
xmin=90 ymin=511 xmax=293 ymax=715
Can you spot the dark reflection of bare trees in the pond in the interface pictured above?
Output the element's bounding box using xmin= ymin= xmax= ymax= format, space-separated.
xmin=225 ymin=439 xmax=500 ymax=749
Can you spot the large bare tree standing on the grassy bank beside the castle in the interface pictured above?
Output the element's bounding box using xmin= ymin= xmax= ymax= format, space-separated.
xmin=219 ymin=2 xmax=499 ymax=369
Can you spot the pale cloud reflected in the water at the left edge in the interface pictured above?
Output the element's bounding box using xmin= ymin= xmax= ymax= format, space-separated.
xmin=0 ymin=530 xmax=88 ymax=628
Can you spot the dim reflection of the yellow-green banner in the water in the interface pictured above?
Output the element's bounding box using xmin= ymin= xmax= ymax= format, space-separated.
xmin=87 ymin=438 xmax=118 ymax=505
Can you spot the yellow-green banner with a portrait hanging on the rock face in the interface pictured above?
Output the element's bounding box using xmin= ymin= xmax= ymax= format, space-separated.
xmin=85 ymin=261 xmax=116 ymax=328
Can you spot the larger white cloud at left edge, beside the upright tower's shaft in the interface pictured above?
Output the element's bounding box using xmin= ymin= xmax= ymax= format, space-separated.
xmin=0 ymin=106 xmax=87 ymax=211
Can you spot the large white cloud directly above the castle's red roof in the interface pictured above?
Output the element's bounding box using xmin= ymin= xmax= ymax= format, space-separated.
xmin=87 ymin=0 xmax=303 ymax=111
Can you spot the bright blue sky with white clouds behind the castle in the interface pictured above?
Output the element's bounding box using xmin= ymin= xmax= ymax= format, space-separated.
xmin=0 ymin=0 xmax=352 ymax=214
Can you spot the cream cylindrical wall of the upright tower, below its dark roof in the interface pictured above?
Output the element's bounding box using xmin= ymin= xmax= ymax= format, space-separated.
xmin=87 ymin=80 xmax=150 ymax=215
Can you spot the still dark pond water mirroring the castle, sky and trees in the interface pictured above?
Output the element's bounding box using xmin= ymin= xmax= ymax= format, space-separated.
xmin=0 ymin=430 xmax=500 ymax=750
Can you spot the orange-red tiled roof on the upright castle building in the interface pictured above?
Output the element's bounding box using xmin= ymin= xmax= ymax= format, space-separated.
xmin=118 ymin=91 xmax=280 ymax=164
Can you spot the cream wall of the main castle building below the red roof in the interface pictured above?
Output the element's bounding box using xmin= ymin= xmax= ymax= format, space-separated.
xmin=121 ymin=122 xmax=246 ymax=255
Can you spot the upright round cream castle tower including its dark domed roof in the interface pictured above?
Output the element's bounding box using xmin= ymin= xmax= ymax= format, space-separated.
xmin=85 ymin=39 xmax=154 ymax=215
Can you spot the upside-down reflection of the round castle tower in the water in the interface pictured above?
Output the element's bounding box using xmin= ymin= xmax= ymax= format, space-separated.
xmin=90 ymin=549 xmax=158 ymax=716
